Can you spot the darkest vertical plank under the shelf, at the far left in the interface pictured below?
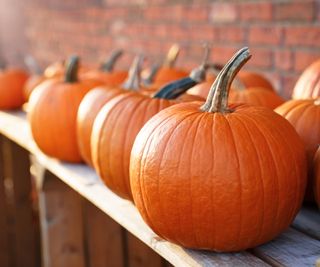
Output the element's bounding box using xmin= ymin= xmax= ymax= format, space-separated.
xmin=3 ymin=138 xmax=40 ymax=266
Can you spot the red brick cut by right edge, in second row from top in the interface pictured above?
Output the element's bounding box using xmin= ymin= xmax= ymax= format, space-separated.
xmin=285 ymin=26 xmax=320 ymax=47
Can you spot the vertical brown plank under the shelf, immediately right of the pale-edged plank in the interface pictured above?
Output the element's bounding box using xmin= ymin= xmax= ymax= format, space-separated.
xmin=83 ymin=200 xmax=125 ymax=267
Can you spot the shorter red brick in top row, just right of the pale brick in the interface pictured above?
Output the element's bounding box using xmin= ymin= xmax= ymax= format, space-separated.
xmin=240 ymin=1 xmax=272 ymax=21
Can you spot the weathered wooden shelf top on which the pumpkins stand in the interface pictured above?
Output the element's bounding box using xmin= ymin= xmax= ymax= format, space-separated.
xmin=0 ymin=111 xmax=320 ymax=266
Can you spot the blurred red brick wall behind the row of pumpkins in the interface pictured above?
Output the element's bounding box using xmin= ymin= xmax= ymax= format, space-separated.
xmin=0 ymin=0 xmax=320 ymax=97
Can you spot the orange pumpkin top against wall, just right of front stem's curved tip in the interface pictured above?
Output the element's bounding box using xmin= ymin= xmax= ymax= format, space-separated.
xmin=237 ymin=71 xmax=274 ymax=91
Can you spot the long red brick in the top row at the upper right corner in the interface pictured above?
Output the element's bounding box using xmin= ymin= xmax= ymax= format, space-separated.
xmin=273 ymin=0 xmax=316 ymax=21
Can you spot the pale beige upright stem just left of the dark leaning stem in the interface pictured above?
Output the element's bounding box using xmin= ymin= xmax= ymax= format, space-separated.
xmin=122 ymin=55 xmax=144 ymax=91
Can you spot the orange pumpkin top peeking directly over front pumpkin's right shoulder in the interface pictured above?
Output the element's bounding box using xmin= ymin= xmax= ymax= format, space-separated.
xmin=229 ymin=87 xmax=284 ymax=109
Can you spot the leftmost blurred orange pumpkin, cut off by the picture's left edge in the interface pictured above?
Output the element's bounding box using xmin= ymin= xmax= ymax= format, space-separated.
xmin=0 ymin=69 xmax=28 ymax=109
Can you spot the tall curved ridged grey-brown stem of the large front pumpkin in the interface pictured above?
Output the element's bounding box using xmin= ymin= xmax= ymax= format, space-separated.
xmin=200 ymin=47 xmax=251 ymax=113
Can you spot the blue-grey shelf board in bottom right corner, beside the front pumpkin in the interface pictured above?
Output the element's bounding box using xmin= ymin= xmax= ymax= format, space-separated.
xmin=253 ymin=229 xmax=320 ymax=267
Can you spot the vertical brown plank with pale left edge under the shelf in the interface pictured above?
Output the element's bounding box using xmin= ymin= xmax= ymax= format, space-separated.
xmin=39 ymin=171 xmax=85 ymax=267
